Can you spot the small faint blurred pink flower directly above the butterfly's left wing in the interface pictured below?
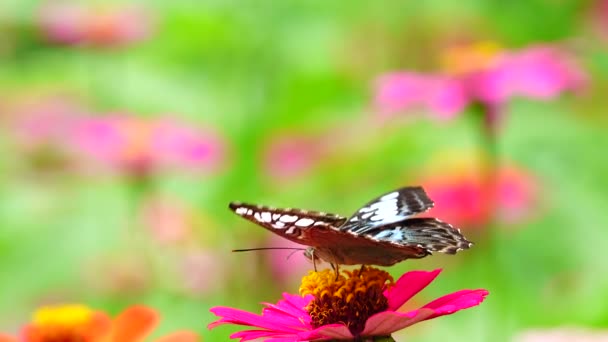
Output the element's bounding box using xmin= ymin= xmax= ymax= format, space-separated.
xmin=264 ymin=135 xmax=325 ymax=179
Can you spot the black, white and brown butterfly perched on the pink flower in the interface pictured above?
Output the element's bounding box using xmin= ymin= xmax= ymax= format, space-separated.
xmin=229 ymin=186 xmax=472 ymax=266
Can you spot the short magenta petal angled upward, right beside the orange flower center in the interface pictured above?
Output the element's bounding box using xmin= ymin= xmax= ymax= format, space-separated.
xmin=384 ymin=269 xmax=441 ymax=311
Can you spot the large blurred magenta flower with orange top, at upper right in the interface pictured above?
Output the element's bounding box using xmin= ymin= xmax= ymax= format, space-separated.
xmin=375 ymin=44 xmax=585 ymax=119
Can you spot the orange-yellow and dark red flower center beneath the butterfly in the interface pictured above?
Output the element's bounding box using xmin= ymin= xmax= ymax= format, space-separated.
xmin=300 ymin=267 xmax=394 ymax=336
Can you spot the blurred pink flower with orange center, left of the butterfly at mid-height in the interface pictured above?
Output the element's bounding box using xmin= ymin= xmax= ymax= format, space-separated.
xmin=74 ymin=114 xmax=225 ymax=176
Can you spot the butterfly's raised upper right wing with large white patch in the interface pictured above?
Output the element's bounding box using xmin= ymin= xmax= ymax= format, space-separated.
xmin=340 ymin=186 xmax=434 ymax=234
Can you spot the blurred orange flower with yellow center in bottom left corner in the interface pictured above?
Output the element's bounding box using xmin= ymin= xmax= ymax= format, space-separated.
xmin=0 ymin=304 xmax=199 ymax=342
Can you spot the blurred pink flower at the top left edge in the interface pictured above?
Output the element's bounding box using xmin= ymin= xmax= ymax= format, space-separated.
xmin=39 ymin=2 xmax=153 ymax=46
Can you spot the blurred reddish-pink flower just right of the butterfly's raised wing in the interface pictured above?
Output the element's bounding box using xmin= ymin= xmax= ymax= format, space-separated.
xmin=419 ymin=166 xmax=538 ymax=229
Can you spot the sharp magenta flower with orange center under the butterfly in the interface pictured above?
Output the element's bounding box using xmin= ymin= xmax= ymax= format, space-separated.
xmin=209 ymin=267 xmax=488 ymax=341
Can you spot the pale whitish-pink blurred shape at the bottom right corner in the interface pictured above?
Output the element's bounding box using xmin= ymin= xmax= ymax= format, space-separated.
xmin=513 ymin=327 xmax=608 ymax=342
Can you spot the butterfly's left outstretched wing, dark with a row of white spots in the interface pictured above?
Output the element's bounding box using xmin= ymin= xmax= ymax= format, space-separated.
xmin=229 ymin=202 xmax=346 ymax=247
